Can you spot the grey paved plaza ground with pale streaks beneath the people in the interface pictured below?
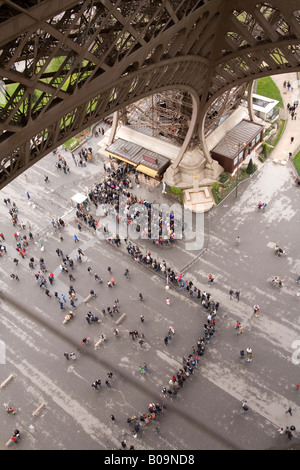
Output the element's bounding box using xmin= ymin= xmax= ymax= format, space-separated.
xmin=0 ymin=73 xmax=300 ymax=451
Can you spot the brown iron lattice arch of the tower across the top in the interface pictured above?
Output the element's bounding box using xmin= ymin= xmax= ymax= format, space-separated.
xmin=0 ymin=0 xmax=300 ymax=188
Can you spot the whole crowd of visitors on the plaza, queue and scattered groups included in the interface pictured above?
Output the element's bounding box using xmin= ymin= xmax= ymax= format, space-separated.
xmin=0 ymin=130 xmax=298 ymax=449
